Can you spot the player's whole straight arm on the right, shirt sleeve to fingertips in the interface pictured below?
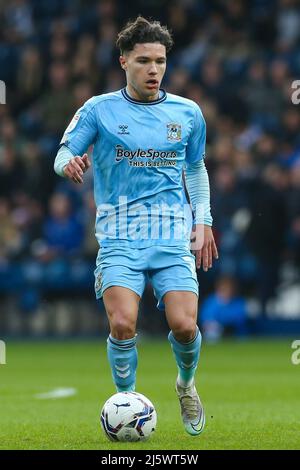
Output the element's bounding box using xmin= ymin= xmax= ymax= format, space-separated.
xmin=186 ymin=104 xmax=218 ymax=271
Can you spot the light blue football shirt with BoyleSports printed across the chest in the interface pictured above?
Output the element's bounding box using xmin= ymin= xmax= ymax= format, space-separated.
xmin=61 ymin=88 xmax=206 ymax=248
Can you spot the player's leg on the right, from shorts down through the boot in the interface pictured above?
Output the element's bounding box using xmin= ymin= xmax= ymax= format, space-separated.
xmin=150 ymin=247 xmax=205 ymax=435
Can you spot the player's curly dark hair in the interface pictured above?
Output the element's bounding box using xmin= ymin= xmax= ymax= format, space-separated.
xmin=116 ymin=16 xmax=173 ymax=54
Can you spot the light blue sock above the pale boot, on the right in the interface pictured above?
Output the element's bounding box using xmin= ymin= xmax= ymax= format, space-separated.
xmin=168 ymin=327 xmax=201 ymax=387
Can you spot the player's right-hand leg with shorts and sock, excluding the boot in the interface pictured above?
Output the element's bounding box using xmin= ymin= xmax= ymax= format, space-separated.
xmin=150 ymin=247 xmax=201 ymax=386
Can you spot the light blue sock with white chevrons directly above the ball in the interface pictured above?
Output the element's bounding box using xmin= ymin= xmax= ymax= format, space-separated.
xmin=107 ymin=335 xmax=137 ymax=392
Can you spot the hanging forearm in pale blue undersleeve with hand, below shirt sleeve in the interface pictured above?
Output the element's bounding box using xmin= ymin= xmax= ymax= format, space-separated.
xmin=185 ymin=159 xmax=218 ymax=271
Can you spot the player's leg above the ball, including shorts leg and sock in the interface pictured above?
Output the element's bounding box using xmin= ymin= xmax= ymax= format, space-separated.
xmin=95 ymin=247 xmax=146 ymax=391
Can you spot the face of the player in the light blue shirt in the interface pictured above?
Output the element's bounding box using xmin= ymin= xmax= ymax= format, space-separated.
xmin=120 ymin=42 xmax=166 ymax=101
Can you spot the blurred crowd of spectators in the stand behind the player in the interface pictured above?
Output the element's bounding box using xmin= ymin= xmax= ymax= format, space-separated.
xmin=0 ymin=0 xmax=300 ymax=311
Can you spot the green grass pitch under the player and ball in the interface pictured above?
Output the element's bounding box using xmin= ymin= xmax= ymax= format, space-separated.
xmin=0 ymin=340 xmax=300 ymax=450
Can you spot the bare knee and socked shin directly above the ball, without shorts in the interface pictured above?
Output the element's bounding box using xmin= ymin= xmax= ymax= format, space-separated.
xmin=103 ymin=286 xmax=140 ymax=392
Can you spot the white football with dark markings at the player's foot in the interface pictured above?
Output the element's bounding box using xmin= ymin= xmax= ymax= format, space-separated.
xmin=101 ymin=392 xmax=157 ymax=442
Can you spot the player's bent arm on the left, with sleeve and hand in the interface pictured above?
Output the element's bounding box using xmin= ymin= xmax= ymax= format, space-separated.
xmin=54 ymin=98 xmax=98 ymax=183
